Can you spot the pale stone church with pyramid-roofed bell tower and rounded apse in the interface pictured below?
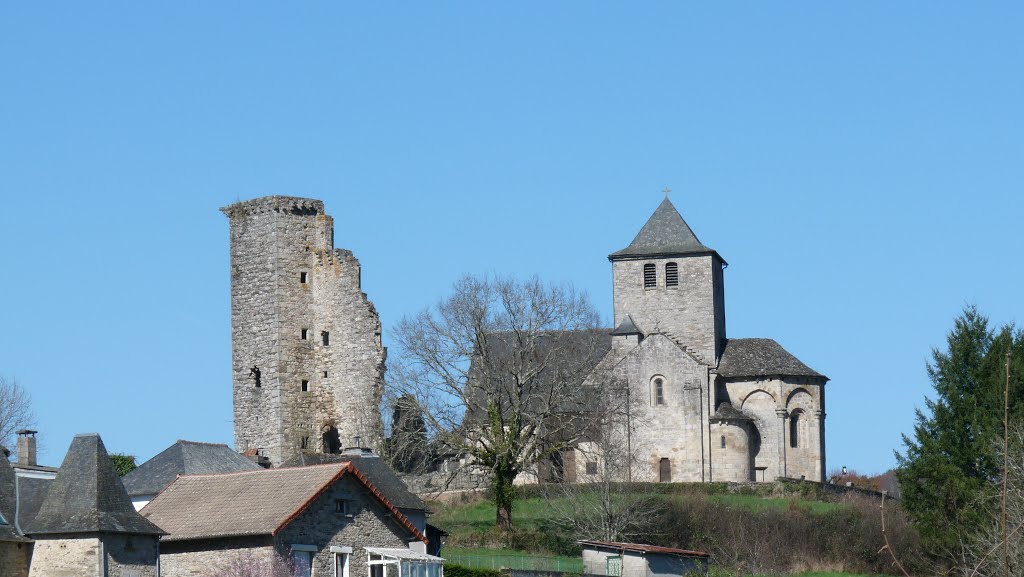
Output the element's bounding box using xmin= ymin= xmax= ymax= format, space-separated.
xmin=573 ymin=197 xmax=828 ymax=482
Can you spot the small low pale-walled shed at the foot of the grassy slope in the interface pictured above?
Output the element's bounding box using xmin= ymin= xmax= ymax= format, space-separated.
xmin=579 ymin=541 xmax=711 ymax=577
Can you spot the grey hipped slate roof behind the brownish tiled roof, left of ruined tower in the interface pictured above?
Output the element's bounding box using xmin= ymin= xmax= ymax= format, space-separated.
xmin=121 ymin=440 xmax=260 ymax=497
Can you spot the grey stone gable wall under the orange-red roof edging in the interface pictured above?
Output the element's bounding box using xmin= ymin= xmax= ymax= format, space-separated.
xmin=276 ymin=476 xmax=412 ymax=577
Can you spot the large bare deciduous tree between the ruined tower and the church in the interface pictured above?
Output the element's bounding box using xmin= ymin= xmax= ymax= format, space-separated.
xmin=389 ymin=277 xmax=608 ymax=530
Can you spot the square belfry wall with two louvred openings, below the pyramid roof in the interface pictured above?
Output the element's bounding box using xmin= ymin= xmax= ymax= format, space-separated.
xmin=611 ymin=255 xmax=725 ymax=366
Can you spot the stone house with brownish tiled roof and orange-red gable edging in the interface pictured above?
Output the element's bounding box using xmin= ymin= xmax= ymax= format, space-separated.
xmin=140 ymin=462 xmax=441 ymax=577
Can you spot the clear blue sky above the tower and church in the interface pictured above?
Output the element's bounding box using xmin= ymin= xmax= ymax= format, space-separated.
xmin=0 ymin=1 xmax=1024 ymax=472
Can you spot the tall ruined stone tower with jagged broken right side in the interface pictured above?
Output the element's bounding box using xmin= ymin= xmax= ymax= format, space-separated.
xmin=221 ymin=196 xmax=386 ymax=466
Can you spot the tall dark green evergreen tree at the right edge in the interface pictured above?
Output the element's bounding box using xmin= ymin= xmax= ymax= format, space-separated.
xmin=896 ymin=306 xmax=1024 ymax=563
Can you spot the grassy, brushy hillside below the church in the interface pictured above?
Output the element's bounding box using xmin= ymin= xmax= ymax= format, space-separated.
xmin=431 ymin=484 xmax=921 ymax=575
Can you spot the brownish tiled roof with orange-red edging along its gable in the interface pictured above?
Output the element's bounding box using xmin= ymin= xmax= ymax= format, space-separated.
xmin=141 ymin=462 xmax=426 ymax=541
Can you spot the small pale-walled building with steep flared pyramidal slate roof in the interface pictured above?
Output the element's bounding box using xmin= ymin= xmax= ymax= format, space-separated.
xmin=23 ymin=434 xmax=164 ymax=577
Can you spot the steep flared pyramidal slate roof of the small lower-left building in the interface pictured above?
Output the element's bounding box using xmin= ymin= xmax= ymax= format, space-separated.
xmin=22 ymin=434 xmax=164 ymax=536
